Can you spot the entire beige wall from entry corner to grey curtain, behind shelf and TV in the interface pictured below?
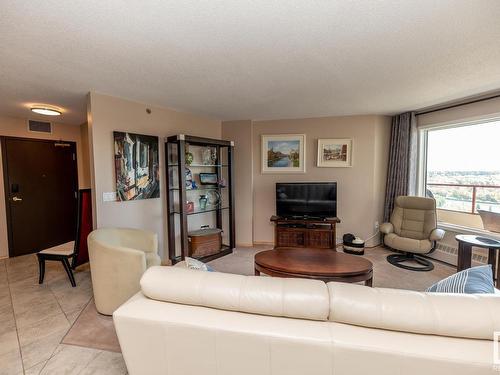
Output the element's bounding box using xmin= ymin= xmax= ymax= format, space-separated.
xmin=88 ymin=97 xmax=390 ymax=258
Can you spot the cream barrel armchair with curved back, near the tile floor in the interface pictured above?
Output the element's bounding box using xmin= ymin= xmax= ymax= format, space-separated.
xmin=88 ymin=228 xmax=161 ymax=315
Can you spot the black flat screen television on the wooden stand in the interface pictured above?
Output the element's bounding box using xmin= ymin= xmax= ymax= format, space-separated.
xmin=276 ymin=182 xmax=337 ymax=219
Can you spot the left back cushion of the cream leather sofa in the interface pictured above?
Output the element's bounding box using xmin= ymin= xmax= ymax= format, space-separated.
xmin=141 ymin=267 xmax=329 ymax=320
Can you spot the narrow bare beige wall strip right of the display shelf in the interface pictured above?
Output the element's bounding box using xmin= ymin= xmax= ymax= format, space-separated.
xmin=222 ymin=120 xmax=254 ymax=246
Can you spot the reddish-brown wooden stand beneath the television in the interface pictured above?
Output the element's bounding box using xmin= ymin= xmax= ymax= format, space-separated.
xmin=271 ymin=216 xmax=340 ymax=249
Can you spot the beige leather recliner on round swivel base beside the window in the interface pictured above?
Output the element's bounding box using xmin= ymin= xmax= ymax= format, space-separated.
xmin=380 ymin=196 xmax=445 ymax=271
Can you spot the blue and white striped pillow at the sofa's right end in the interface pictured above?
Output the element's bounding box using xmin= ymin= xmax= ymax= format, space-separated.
xmin=426 ymin=264 xmax=495 ymax=294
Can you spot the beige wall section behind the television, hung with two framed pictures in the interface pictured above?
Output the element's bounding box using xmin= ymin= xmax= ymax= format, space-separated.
xmin=250 ymin=116 xmax=390 ymax=244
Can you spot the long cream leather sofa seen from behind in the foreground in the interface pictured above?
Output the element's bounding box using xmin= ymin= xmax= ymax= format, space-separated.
xmin=113 ymin=267 xmax=500 ymax=375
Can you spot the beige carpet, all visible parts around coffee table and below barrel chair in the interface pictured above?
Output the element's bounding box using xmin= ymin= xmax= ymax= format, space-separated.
xmin=62 ymin=246 xmax=456 ymax=352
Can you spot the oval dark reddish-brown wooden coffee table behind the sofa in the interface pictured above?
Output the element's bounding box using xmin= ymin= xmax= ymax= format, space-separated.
xmin=255 ymin=248 xmax=373 ymax=286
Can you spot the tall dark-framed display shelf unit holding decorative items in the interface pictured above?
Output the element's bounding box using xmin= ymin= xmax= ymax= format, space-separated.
xmin=165 ymin=134 xmax=235 ymax=264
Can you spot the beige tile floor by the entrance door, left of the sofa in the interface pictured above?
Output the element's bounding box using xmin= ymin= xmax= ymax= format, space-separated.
xmin=0 ymin=255 xmax=127 ymax=375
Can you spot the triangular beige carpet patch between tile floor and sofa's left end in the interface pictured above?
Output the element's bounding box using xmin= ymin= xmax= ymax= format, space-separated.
xmin=62 ymin=299 xmax=121 ymax=353
